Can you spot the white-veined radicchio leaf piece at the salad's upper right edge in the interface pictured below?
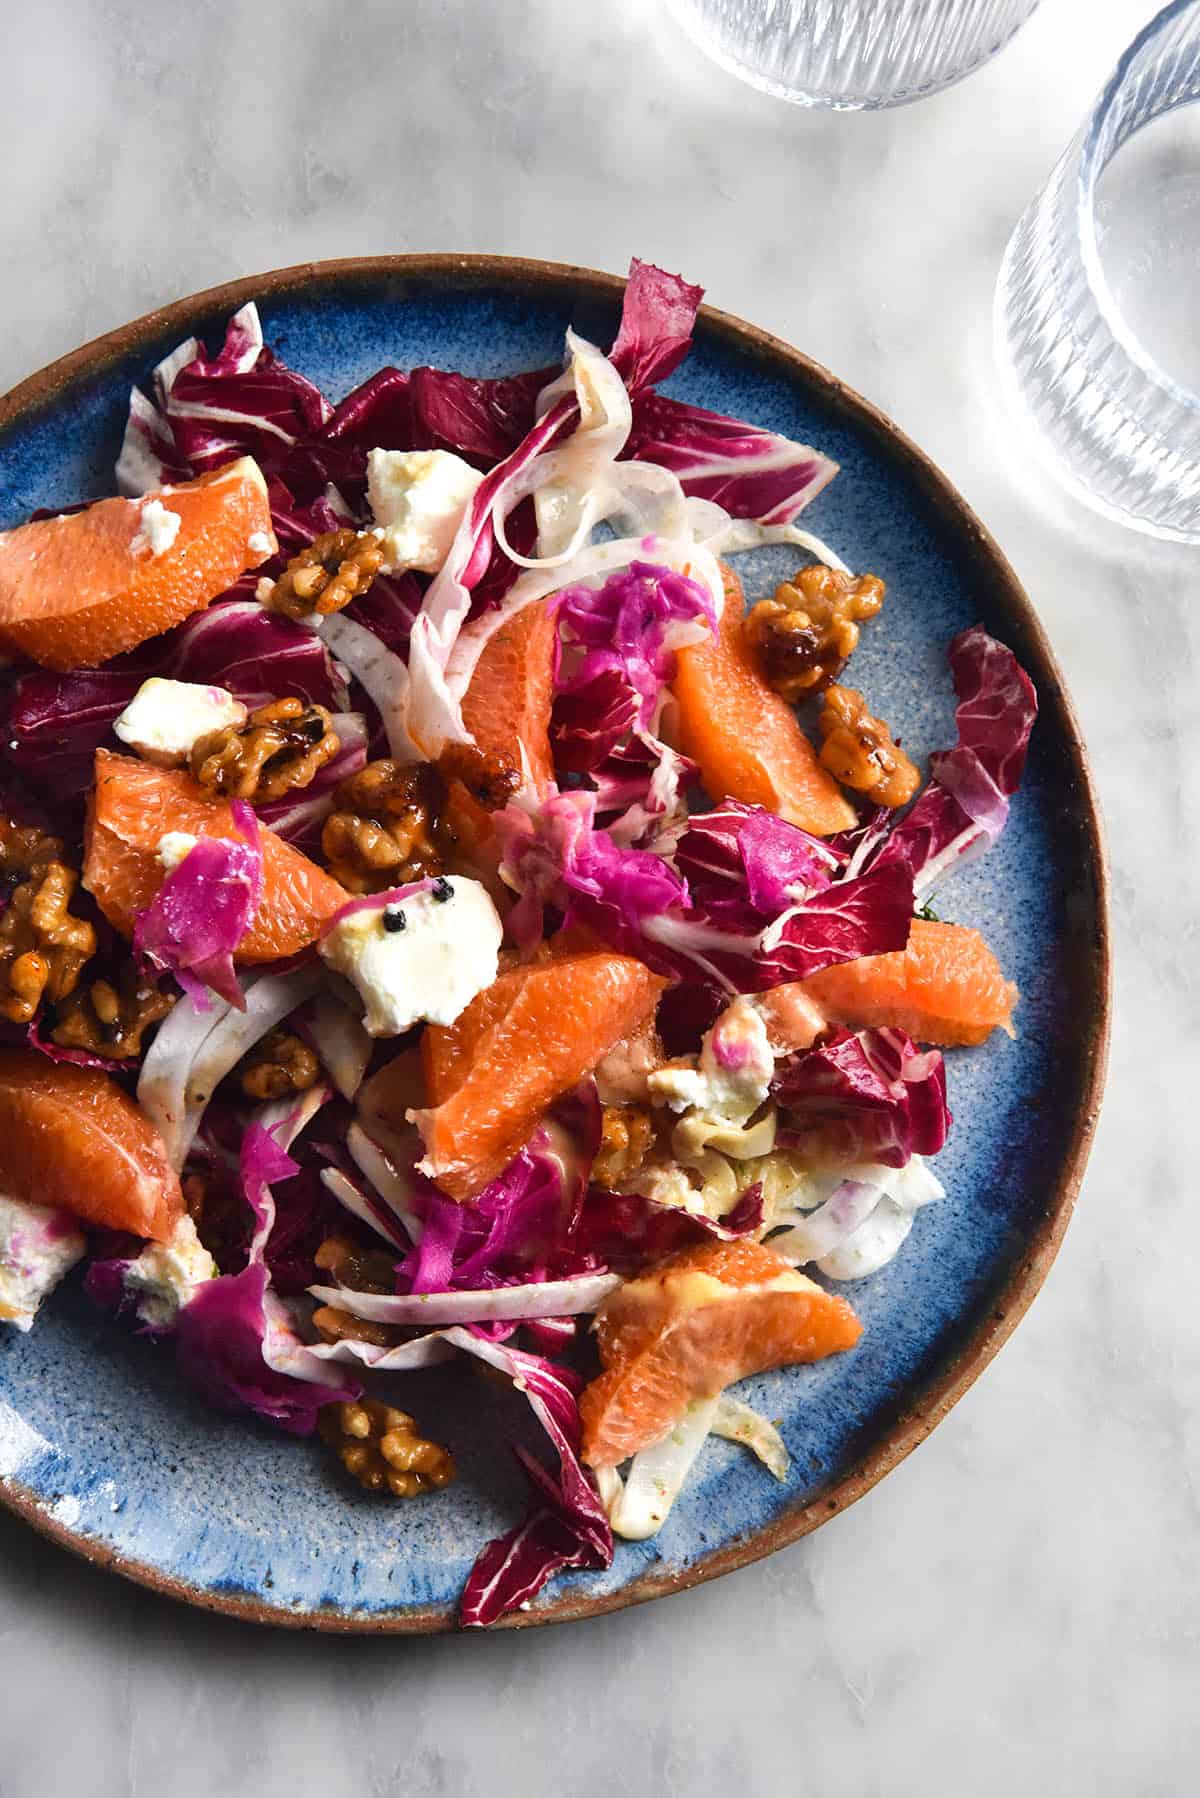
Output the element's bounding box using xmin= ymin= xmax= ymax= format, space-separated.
xmin=624 ymin=394 xmax=838 ymax=525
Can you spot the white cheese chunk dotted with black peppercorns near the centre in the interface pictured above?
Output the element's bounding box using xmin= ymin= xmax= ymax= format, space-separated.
xmin=320 ymin=876 xmax=504 ymax=1036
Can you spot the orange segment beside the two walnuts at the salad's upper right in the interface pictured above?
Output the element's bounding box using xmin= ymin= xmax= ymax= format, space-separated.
xmin=673 ymin=568 xmax=856 ymax=836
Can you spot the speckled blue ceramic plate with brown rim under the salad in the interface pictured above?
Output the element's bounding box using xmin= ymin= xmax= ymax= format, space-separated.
xmin=0 ymin=257 xmax=1108 ymax=1631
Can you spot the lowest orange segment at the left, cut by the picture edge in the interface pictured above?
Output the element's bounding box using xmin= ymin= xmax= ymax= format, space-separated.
xmin=0 ymin=1048 xmax=184 ymax=1242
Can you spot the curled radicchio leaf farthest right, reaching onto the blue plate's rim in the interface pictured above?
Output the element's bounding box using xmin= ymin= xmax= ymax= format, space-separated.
xmin=874 ymin=624 xmax=1038 ymax=903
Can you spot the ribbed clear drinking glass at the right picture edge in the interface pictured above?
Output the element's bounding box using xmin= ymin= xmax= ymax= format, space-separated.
xmin=995 ymin=0 xmax=1200 ymax=543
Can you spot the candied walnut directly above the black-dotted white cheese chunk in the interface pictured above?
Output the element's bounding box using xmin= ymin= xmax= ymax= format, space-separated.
xmin=320 ymin=759 xmax=441 ymax=894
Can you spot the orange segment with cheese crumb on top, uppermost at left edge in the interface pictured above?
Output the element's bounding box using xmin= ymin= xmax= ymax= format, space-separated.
xmin=0 ymin=457 xmax=277 ymax=669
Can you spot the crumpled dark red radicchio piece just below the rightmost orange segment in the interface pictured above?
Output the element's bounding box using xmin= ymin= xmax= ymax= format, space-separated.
xmin=772 ymin=1030 xmax=952 ymax=1167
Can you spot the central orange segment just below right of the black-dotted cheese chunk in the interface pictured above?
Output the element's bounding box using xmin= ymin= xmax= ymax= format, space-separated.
xmin=416 ymin=949 xmax=666 ymax=1201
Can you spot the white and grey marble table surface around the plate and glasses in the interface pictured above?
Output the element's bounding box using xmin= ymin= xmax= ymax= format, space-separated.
xmin=0 ymin=0 xmax=1200 ymax=1798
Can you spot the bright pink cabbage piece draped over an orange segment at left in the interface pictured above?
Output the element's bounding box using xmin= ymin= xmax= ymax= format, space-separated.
xmin=133 ymin=800 xmax=263 ymax=1010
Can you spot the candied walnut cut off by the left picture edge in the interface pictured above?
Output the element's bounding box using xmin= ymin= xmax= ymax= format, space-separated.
xmin=0 ymin=820 xmax=95 ymax=1023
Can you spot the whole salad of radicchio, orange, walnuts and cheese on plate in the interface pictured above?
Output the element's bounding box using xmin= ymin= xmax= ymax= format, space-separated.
xmin=0 ymin=261 xmax=1036 ymax=1625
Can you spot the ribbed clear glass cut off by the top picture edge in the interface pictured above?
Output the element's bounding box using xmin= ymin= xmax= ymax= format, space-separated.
xmin=667 ymin=0 xmax=1040 ymax=111
